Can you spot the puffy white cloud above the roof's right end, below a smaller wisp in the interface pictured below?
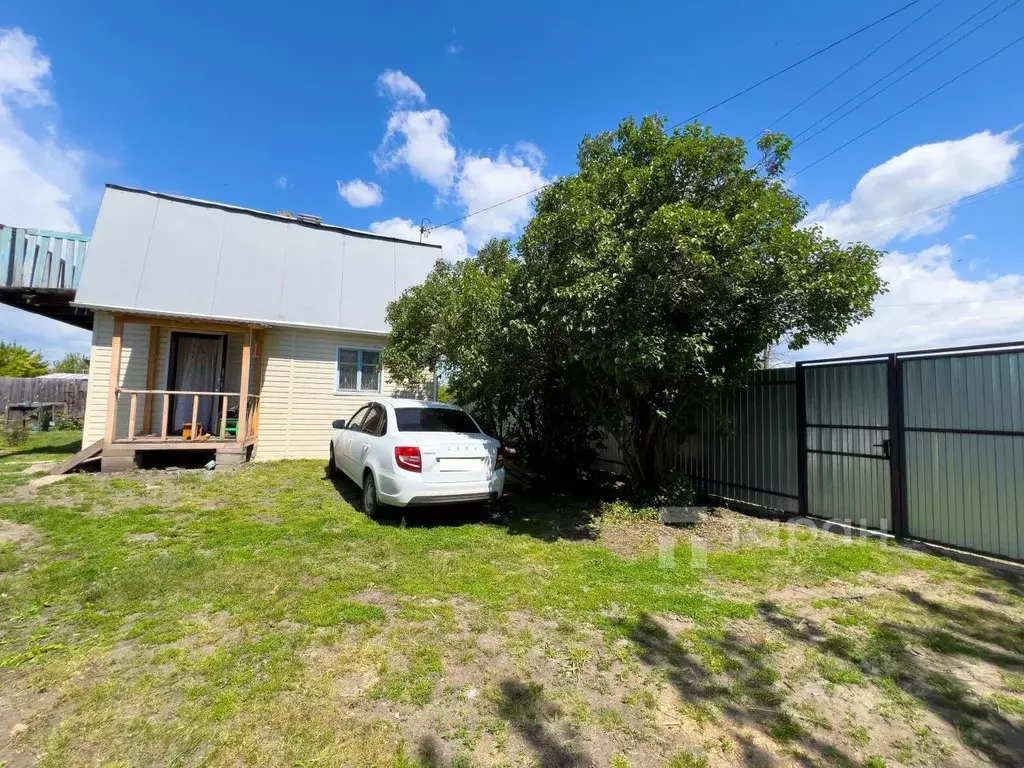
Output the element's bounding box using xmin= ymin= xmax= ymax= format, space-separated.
xmin=374 ymin=110 xmax=458 ymax=193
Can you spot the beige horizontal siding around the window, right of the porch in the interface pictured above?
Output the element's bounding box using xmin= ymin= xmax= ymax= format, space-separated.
xmin=256 ymin=329 xmax=421 ymax=461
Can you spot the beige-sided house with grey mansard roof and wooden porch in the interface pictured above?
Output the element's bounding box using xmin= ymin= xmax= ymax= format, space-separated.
xmin=74 ymin=184 xmax=441 ymax=470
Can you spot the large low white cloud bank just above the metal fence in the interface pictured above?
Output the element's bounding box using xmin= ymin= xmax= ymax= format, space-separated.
xmin=797 ymin=245 xmax=1024 ymax=358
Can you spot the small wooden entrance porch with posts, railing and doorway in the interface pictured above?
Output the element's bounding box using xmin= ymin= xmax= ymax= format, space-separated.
xmin=100 ymin=314 xmax=265 ymax=471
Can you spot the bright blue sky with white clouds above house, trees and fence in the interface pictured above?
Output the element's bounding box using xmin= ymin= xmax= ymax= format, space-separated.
xmin=0 ymin=0 xmax=1024 ymax=364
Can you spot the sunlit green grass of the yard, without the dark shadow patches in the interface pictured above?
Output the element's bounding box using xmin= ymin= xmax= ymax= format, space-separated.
xmin=0 ymin=433 xmax=1024 ymax=766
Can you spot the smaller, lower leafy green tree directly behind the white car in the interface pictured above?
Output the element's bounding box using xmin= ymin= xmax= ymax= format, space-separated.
xmin=384 ymin=240 xmax=596 ymax=473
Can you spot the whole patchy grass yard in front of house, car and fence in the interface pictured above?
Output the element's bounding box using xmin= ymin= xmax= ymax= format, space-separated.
xmin=0 ymin=433 xmax=1024 ymax=768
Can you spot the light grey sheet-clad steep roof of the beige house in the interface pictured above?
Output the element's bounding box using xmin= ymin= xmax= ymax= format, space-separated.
xmin=75 ymin=184 xmax=441 ymax=334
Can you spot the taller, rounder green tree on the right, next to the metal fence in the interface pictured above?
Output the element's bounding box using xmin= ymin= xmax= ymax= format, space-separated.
xmin=512 ymin=117 xmax=883 ymax=487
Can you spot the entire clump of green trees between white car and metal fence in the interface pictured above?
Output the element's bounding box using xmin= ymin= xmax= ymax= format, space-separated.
xmin=385 ymin=117 xmax=884 ymax=488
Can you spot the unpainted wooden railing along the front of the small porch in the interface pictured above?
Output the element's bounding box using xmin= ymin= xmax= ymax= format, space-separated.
xmin=117 ymin=388 xmax=259 ymax=442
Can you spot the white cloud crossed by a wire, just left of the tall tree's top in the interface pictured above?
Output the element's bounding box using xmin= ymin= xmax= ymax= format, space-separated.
xmin=456 ymin=142 xmax=548 ymax=247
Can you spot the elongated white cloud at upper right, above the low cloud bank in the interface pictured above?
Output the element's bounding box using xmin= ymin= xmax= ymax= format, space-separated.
xmin=806 ymin=131 xmax=1021 ymax=245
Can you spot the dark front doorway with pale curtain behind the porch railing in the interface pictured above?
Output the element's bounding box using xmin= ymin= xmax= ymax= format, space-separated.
xmin=167 ymin=331 xmax=227 ymax=434
